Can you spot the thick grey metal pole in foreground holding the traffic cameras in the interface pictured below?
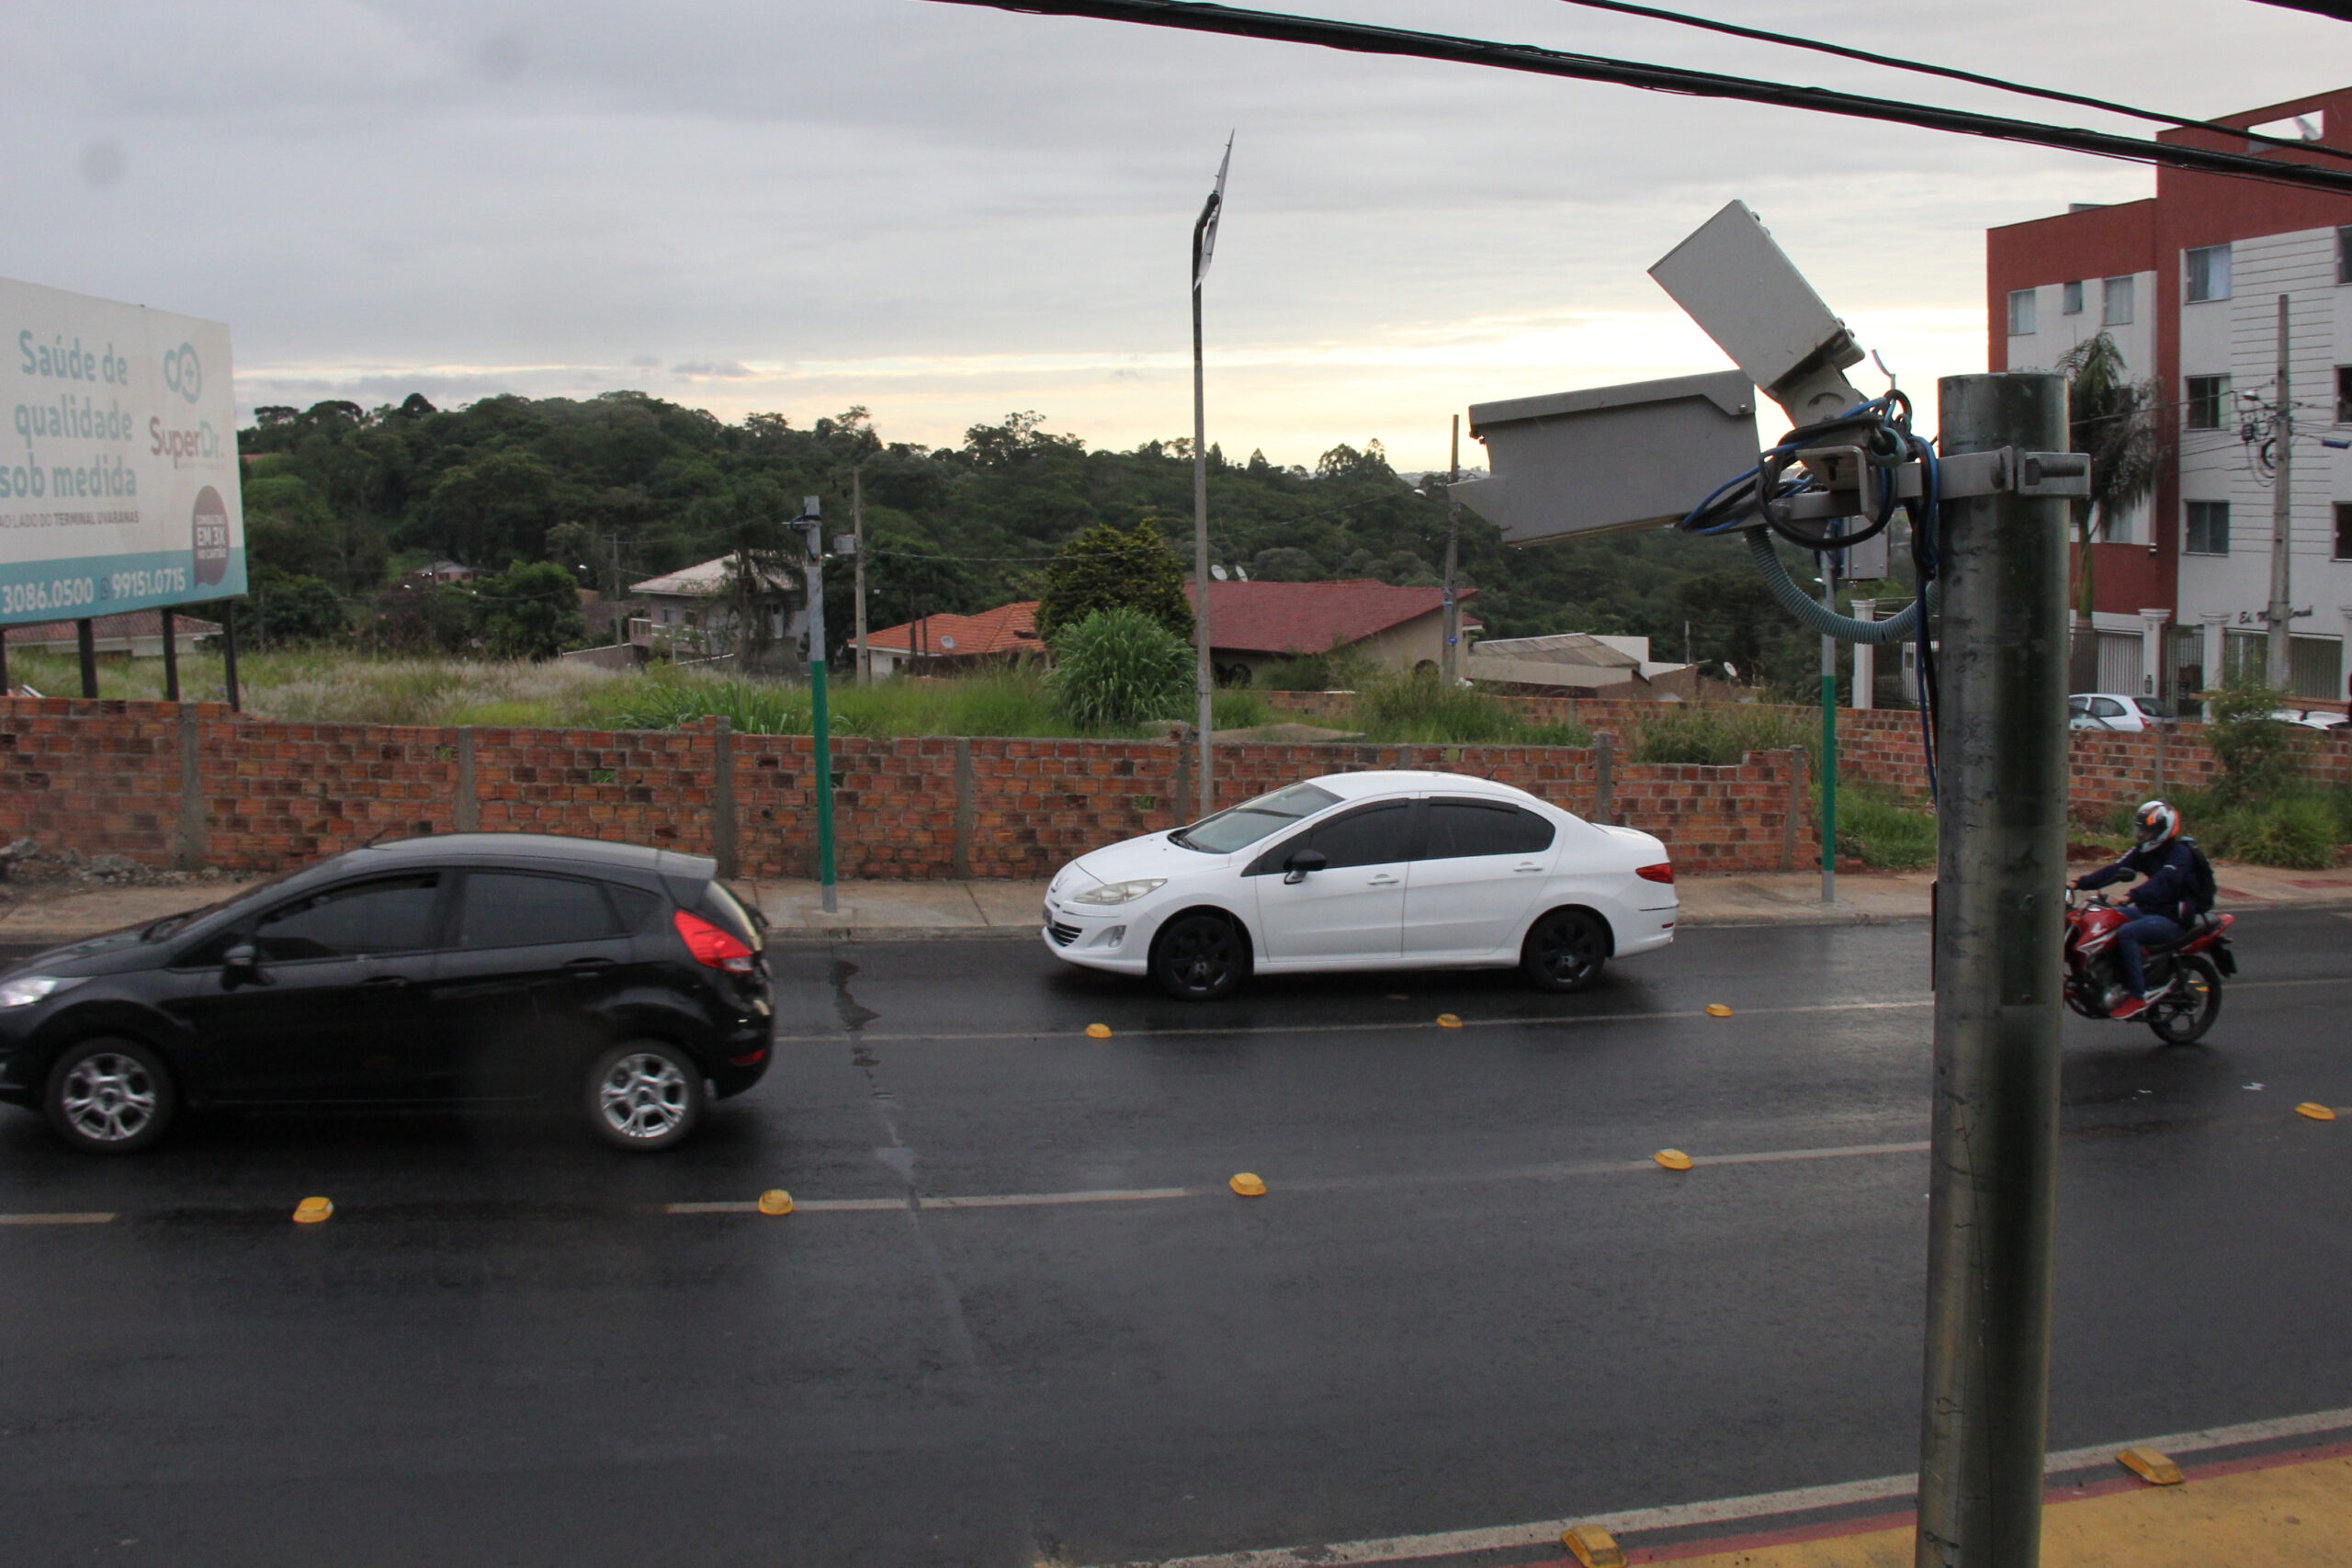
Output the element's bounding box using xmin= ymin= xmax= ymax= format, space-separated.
xmin=1917 ymin=374 xmax=2067 ymax=1568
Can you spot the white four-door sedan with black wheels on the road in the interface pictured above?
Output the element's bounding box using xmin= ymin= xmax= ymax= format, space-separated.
xmin=1045 ymin=771 xmax=1677 ymax=1001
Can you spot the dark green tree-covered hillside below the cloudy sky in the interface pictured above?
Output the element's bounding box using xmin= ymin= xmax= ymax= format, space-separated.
xmin=240 ymin=392 xmax=1891 ymax=691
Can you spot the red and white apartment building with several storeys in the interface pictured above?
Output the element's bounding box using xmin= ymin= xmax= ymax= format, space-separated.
xmin=1985 ymin=87 xmax=2352 ymax=701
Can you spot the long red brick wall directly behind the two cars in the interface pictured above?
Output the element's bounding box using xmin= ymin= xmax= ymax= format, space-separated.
xmin=0 ymin=698 xmax=1818 ymax=879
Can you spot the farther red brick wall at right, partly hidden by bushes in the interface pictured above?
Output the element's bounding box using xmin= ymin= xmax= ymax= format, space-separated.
xmin=1265 ymin=691 xmax=2352 ymax=818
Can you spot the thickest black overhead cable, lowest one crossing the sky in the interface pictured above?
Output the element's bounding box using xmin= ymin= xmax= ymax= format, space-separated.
xmin=933 ymin=0 xmax=2352 ymax=195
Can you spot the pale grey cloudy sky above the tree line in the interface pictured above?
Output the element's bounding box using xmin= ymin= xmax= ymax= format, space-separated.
xmin=0 ymin=0 xmax=2352 ymax=468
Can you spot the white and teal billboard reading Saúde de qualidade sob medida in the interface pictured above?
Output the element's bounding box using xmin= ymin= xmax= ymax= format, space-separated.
xmin=0 ymin=280 xmax=244 ymax=626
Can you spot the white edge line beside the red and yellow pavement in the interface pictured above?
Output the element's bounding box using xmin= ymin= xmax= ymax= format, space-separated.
xmin=1086 ymin=1411 xmax=2352 ymax=1568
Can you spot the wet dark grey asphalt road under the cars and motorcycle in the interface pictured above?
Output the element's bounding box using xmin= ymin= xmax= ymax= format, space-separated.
xmin=0 ymin=912 xmax=2352 ymax=1568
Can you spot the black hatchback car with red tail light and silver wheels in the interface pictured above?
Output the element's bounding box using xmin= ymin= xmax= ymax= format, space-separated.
xmin=0 ymin=832 xmax=774 ymax=1152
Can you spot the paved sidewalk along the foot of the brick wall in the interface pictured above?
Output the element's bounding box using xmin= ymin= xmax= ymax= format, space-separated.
xmin=0 ymin=861 xmax=2352 ymax=945
